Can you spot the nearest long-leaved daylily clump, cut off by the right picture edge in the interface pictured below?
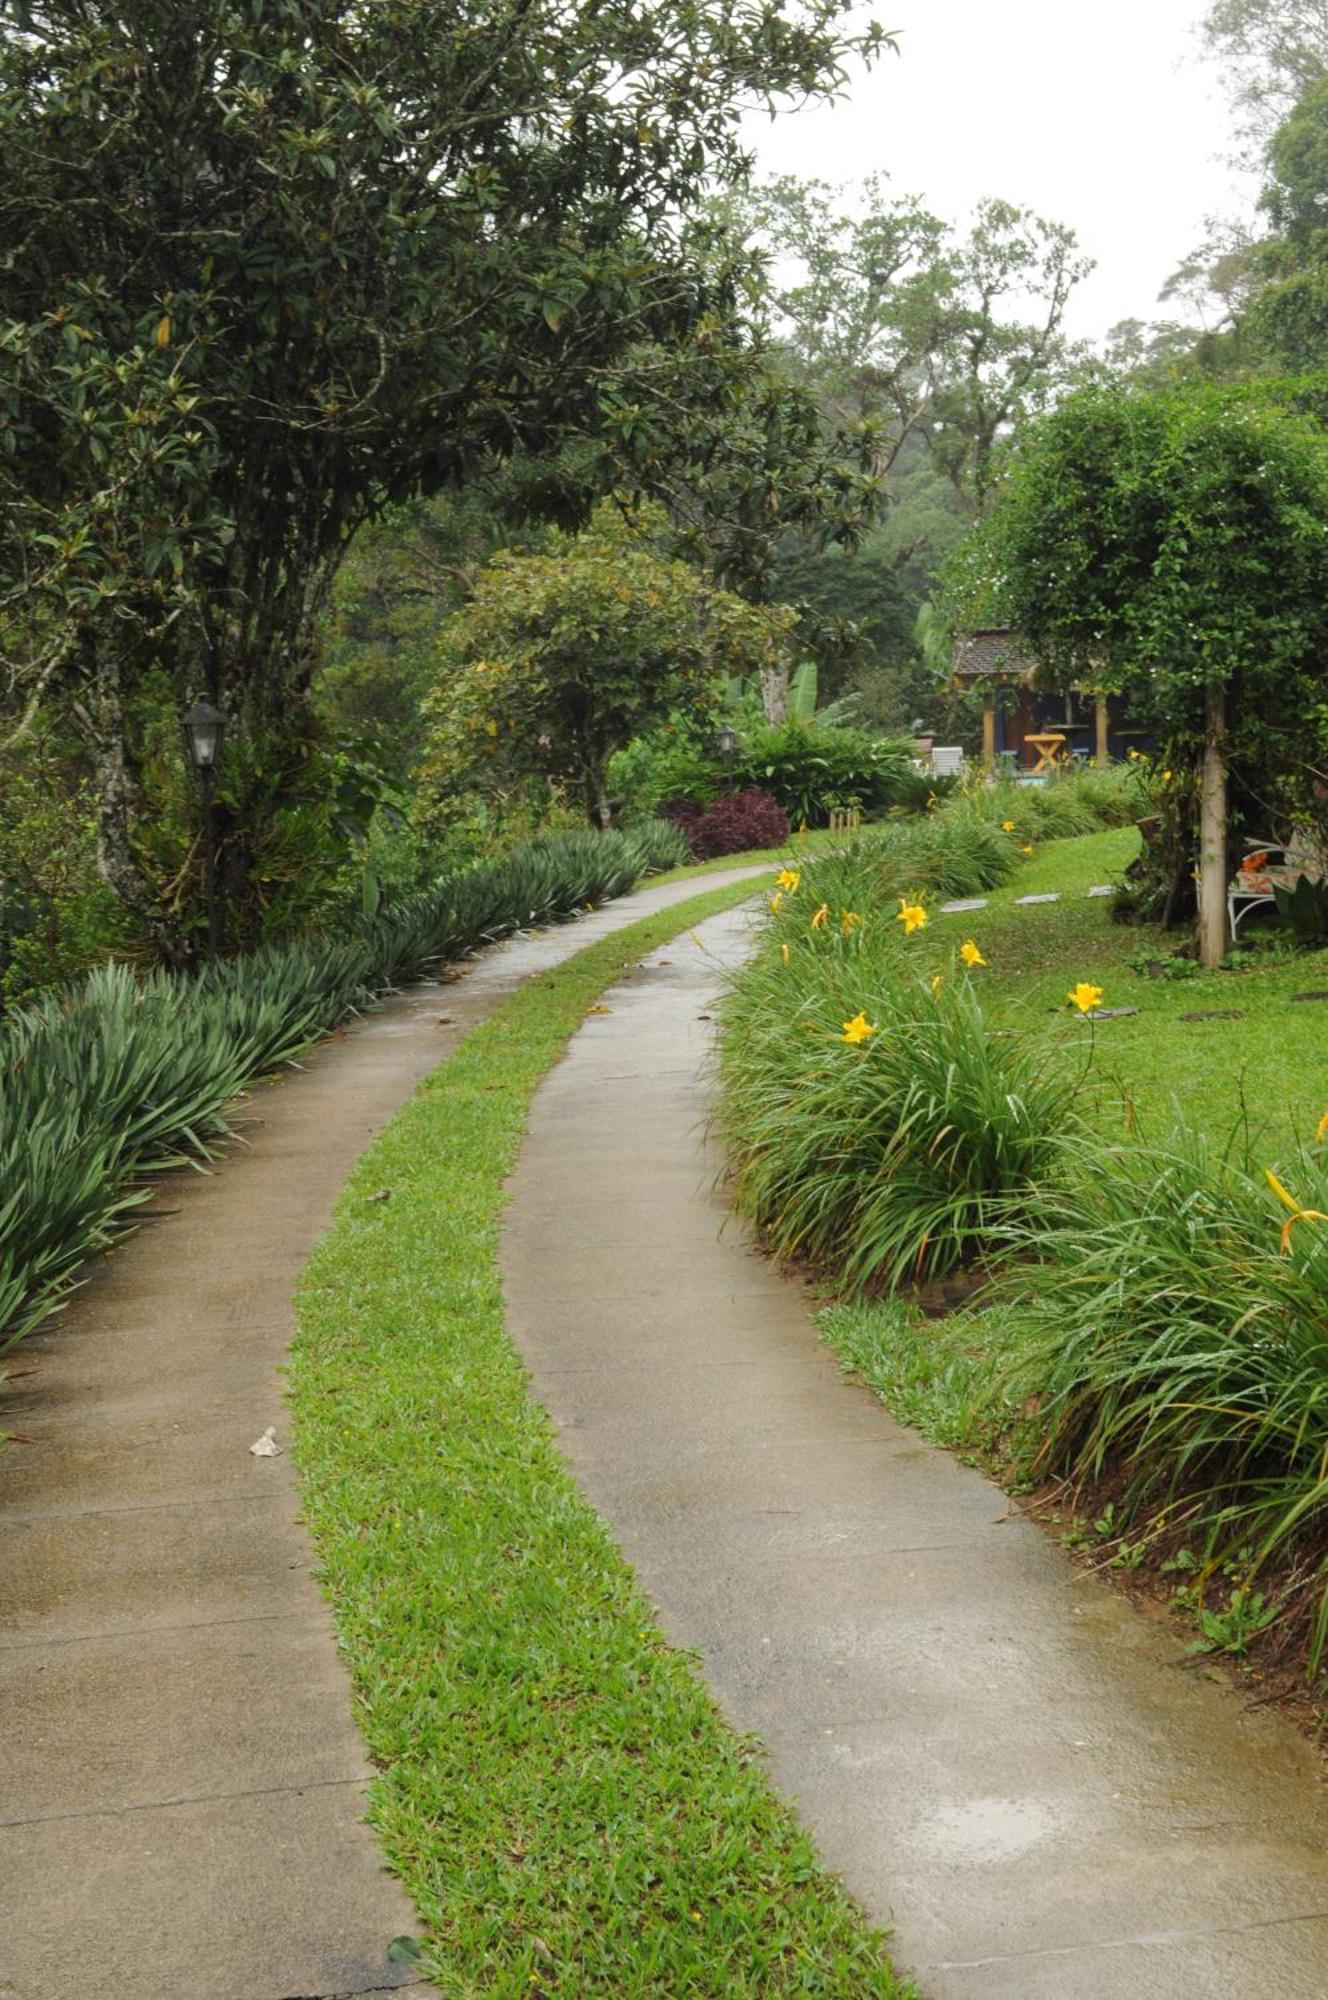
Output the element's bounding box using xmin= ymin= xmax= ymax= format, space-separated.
xmin=1012 ymin=1124 xmax=1328 ymax=1668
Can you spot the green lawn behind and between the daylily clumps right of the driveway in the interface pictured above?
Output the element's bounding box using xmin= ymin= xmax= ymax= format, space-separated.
xmin=820 ymin=830 xmax=1328 ymax=1656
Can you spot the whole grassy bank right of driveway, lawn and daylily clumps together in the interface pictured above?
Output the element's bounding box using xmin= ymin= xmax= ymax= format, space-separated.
xmin=724 ymin=828 xmax=1328 ymax=1686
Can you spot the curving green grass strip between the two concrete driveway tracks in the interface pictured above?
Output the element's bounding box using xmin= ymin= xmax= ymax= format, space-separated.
xmin=290 ymin=884 xmax=912 ymax=2000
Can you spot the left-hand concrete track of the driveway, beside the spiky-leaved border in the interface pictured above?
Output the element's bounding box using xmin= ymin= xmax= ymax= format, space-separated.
xmin=0 ymin=866 xmax=770 ymax=2000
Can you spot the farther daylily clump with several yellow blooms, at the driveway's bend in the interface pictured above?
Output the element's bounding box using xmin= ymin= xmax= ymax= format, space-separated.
xmin=720 ymin=774 xmax=1136 ymax=1290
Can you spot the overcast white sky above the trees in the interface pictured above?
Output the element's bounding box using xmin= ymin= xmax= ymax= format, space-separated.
xmin=748 ymin=0 xmax=1250 ymax=338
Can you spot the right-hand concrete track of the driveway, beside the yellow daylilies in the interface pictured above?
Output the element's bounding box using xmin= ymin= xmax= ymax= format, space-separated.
xmin=504 ymin=916 xmax=1328 ymax=2000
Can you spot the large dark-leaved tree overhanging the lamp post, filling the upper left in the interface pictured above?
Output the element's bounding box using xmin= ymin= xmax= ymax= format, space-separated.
xmin=0 ymin=0 xmax=878 ymax=946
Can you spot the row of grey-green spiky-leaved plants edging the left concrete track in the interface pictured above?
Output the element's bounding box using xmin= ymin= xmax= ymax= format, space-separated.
xmin=0 ymin=822 xmax=690 ymax=1352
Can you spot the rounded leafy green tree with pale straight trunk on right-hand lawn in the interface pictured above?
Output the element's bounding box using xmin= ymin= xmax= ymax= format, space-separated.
xmin=968 ymin=388 xmax=1328 ymax=966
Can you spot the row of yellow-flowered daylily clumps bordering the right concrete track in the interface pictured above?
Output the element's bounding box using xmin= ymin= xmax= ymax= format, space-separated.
xmin=720 ymin=806 xmax=1328 ymax=1674
